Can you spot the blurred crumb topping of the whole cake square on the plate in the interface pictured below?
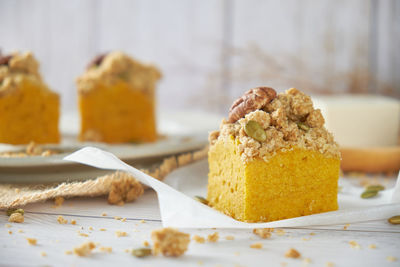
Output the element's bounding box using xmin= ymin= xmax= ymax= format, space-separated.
xmin=76 ymin=51 xmax=161 ymax=95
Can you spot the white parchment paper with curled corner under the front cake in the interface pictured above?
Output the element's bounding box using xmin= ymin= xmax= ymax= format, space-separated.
xmin=64 ymin=147 xmax=400 ymax=228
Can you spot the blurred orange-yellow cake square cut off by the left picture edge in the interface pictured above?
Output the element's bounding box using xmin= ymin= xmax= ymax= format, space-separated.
xmin=0 ymin=52 xmax=60 ymax=144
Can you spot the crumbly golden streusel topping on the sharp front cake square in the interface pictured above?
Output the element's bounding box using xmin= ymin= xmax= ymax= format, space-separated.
xmin=209 ymin=88 xmax=340 ymax=162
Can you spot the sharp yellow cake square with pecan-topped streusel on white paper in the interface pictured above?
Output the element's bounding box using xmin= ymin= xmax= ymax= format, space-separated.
xmin=207 ymin=87 xmax=340 ymax=222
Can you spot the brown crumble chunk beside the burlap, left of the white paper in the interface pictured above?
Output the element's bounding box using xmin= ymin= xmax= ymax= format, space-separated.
xmin=108 ymin=172 xmax=144 ymax=205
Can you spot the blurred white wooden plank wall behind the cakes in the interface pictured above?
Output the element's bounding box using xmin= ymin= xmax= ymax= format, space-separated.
xmin=0 ymin=0 xmax=400 ymax=113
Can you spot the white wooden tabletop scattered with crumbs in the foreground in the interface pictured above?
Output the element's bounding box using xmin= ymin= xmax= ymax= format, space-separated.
xmin=0 ymin=190 xmax=400 ymax=267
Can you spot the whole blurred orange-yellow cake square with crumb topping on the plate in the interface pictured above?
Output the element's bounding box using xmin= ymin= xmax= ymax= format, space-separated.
xmin=77 ymin=51 xmax=161 ymax=143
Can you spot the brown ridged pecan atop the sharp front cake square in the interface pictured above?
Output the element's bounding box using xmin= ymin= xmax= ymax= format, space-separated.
xmin=228 ymin=87 xmax=276 ymax=123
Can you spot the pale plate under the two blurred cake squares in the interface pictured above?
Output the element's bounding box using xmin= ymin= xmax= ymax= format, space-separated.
xmin=0 ymin=111 xmax=222 ymax=183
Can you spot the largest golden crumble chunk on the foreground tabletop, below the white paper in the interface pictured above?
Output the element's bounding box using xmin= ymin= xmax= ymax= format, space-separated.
xmin=151 ymin=227 xmax=190 ymax=257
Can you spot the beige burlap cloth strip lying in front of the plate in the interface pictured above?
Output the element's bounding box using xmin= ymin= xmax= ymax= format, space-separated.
xmin=0 ymin=147 xmax=208 ymax=208
